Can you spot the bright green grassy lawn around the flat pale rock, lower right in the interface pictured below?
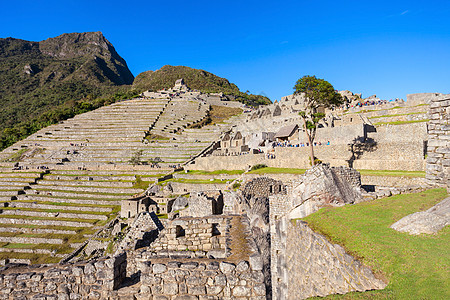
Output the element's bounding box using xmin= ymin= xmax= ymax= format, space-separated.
xmin=304 ymin=189 xmax=450 ymax=299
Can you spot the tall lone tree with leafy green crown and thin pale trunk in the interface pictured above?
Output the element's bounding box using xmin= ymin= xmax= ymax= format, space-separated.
xmin=294 ymin=75 xmax=343 ymax=166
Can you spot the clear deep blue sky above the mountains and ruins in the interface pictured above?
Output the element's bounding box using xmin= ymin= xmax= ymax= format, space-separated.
xmin=0 ymin=0 xmax=450 ymax=100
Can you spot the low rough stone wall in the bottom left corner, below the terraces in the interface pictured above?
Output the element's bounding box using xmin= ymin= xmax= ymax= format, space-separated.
xmin=0 ymin=254 xmax=126 ymax=300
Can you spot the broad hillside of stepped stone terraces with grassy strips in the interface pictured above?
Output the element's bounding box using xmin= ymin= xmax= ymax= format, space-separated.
xmin=0 ymin=97 xmax=243 ymax=263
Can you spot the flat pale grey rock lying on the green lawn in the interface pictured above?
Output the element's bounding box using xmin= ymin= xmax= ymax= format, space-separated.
xmin=391 ymin=197 xmax=450 ymax=235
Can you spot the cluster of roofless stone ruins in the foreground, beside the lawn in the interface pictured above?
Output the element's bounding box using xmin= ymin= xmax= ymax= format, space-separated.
xmin=0 ymin=165 xmax=385 ymax=299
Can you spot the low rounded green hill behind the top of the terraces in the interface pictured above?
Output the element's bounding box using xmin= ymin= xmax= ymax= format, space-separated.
xmin=133 ymin=65 xmax=272 ymax=106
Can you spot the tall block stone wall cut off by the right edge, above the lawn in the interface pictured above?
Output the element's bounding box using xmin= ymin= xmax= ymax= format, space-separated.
xmin=426 ymin=95 xmax=450 ymax=188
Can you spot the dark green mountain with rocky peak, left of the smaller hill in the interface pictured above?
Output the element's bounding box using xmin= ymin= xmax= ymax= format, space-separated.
xmin=0 ymin=32 xmax=134 ymax=149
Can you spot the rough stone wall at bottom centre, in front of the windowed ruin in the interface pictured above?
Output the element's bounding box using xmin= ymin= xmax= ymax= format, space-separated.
xmin=135 ymin=260 xmax=266 ymax=300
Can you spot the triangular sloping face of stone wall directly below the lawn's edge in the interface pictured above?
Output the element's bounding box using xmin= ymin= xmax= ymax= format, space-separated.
xmin=284 ymin=221 xmax=386 ymax=299
